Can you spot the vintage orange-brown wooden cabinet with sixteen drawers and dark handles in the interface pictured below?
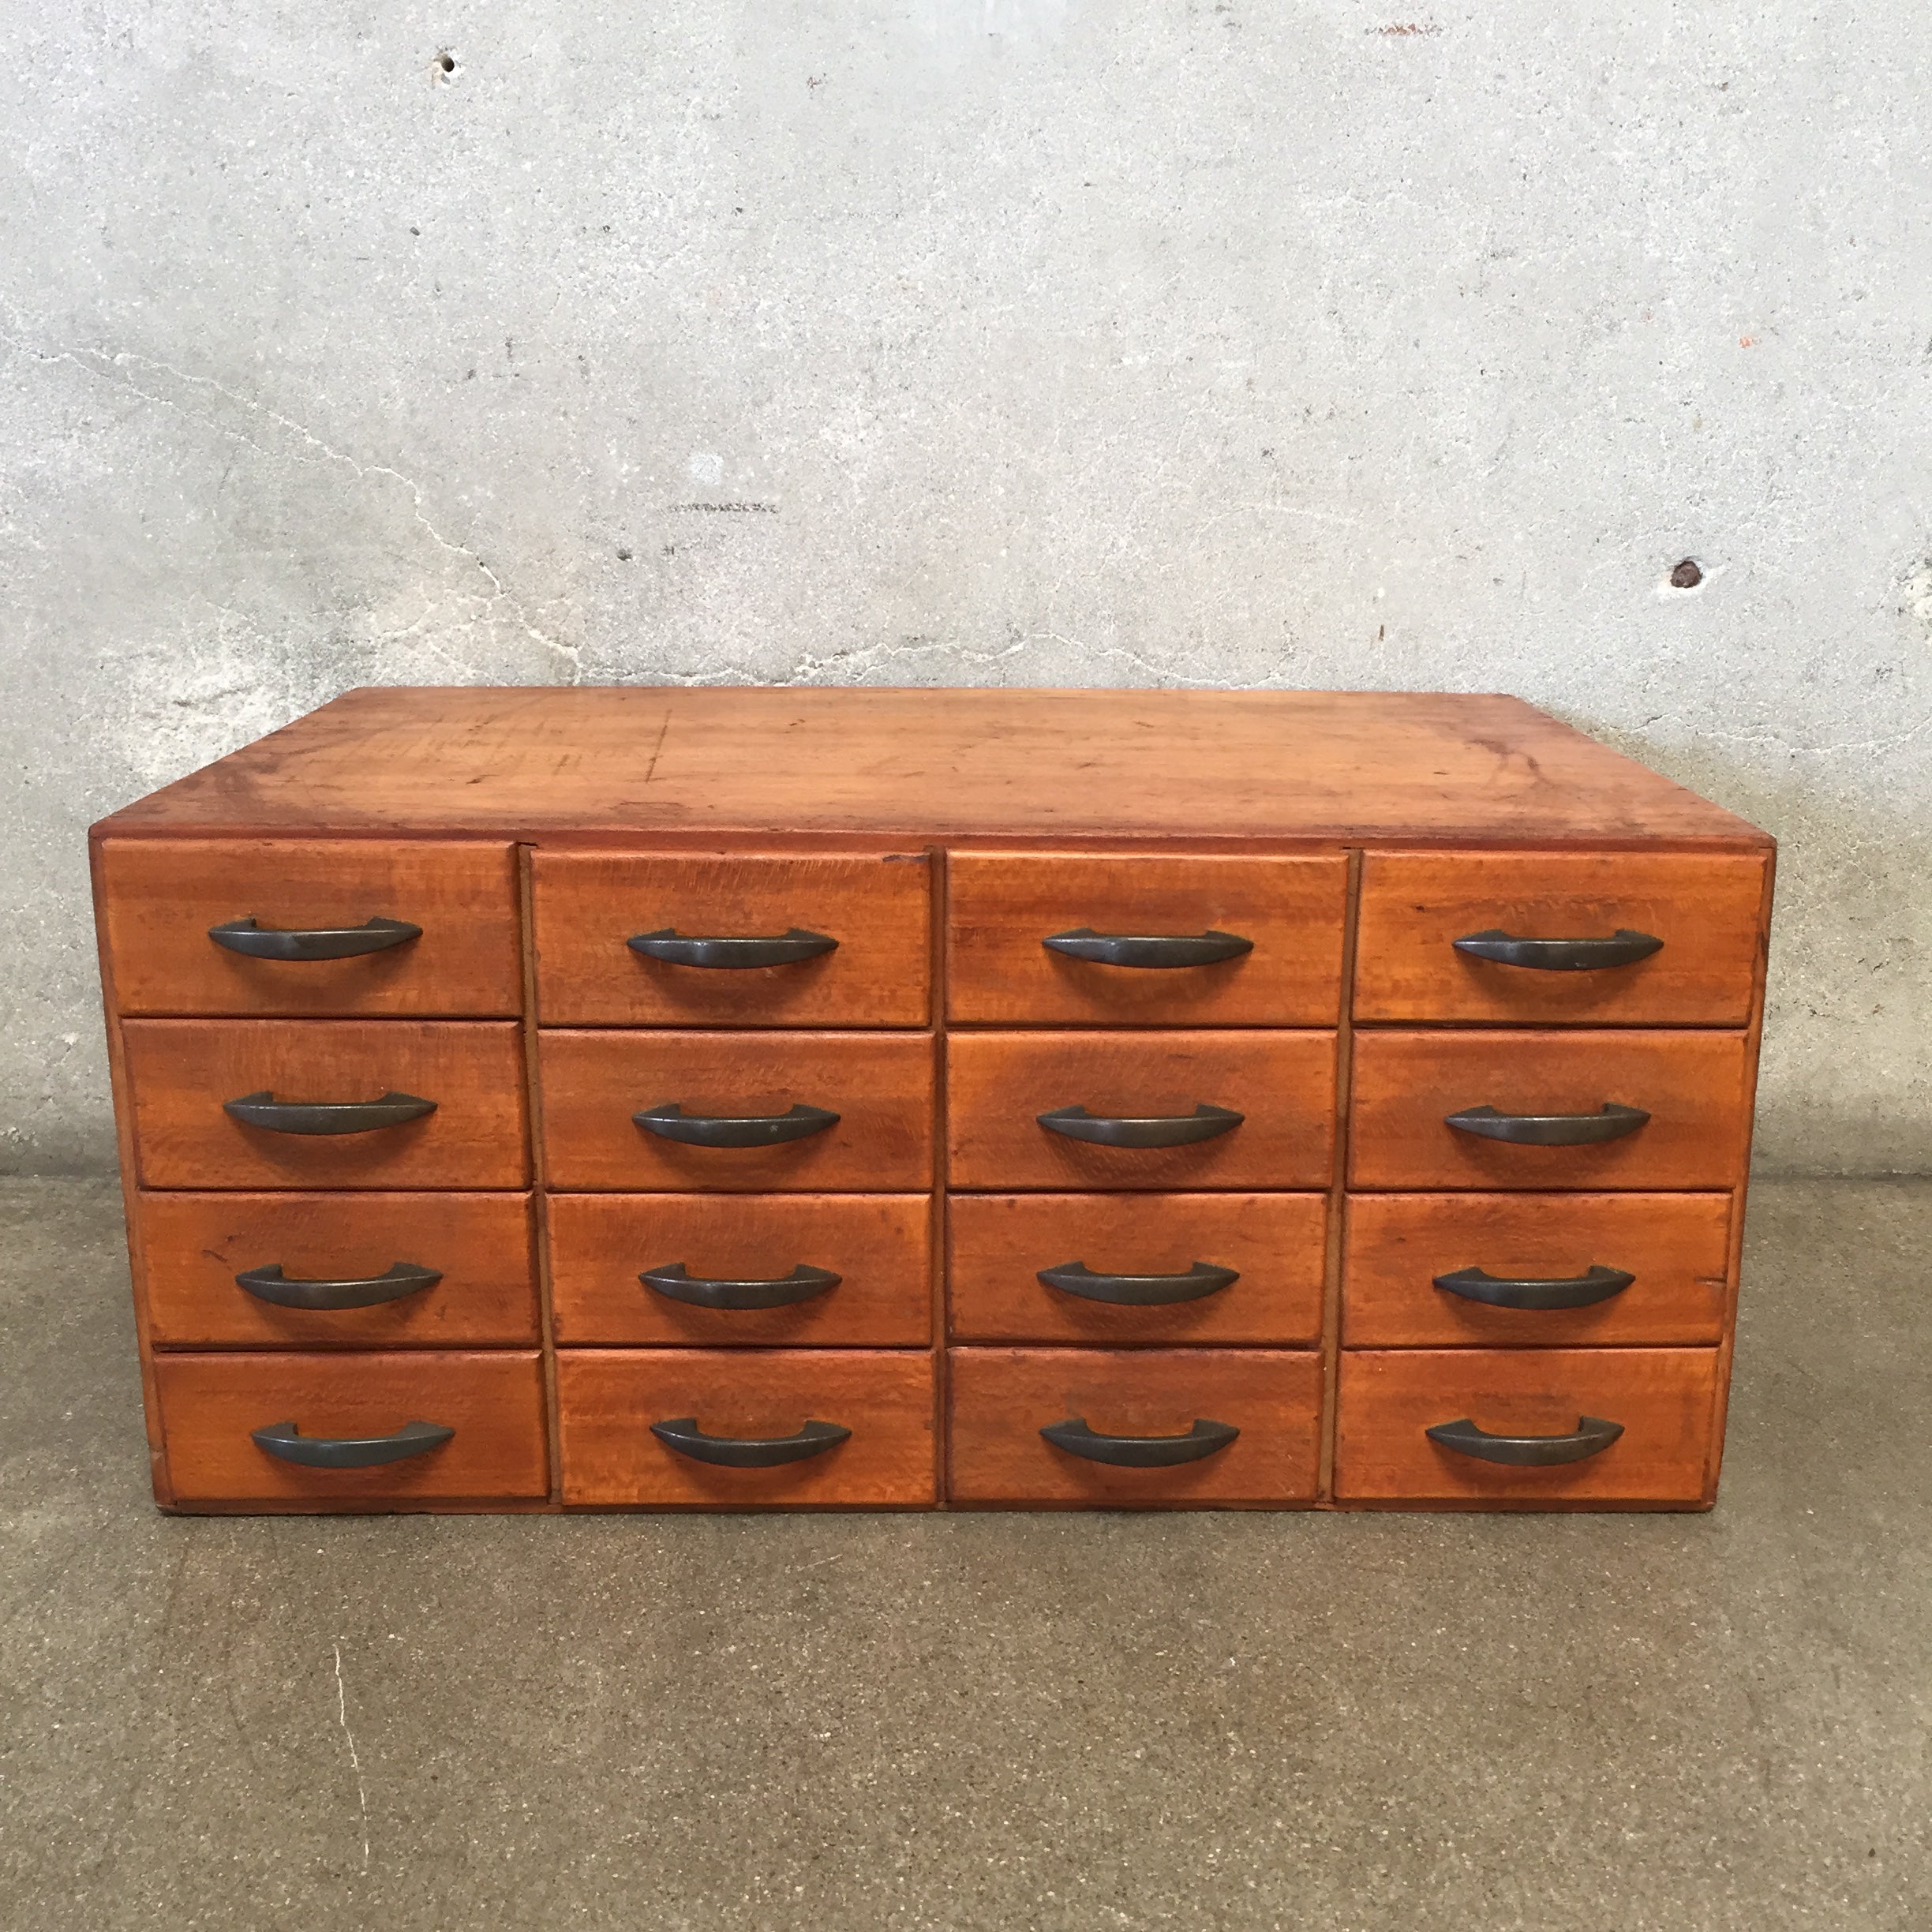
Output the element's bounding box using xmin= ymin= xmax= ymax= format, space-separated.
xmin=95 ymin=690 xmax=1772 ymax=1511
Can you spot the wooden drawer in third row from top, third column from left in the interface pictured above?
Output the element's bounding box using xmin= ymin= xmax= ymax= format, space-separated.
xmin=947 ymin=1194 xmax=1327 ymax=1345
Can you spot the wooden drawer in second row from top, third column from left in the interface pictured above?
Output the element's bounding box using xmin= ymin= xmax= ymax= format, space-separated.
xmin=947 ymin=1032 xmax=1335 ymax=1192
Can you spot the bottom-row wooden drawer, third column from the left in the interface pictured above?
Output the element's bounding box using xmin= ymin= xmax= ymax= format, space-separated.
xmin=950 ymin=1349 xmax=1321 ymax=1509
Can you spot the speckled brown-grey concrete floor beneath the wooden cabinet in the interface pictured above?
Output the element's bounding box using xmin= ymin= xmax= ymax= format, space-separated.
xmin=0 ymin=1182 xmax=1932 ymax=1932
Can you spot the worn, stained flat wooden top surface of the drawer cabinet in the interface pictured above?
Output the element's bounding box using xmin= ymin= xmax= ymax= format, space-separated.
xmin=96 ymin=686 xmax=1769 ymax=848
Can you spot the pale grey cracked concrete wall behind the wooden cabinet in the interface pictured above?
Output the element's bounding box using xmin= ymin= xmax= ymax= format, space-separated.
xmin=0 ymin=0 xmax=1932 ymax=1173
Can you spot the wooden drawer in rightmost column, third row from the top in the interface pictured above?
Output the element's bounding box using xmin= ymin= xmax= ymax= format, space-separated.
xmin=1341 ymin=1194 xmax=1731 ymax=1349
